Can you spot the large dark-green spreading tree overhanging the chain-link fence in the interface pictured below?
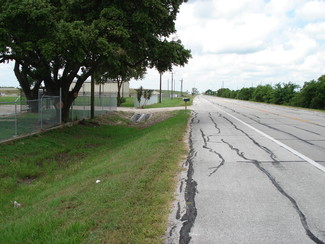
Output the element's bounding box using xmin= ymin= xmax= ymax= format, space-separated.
xmin=0 ymin=0 xmax=189 ymax=120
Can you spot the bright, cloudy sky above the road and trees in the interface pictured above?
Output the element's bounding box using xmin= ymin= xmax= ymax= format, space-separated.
xmin=0 ymin=0 xmax=325 ymax=92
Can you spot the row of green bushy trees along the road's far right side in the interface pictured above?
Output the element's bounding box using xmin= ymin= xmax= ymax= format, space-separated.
xmin=205 ymin=75 xmax=325 ymax=110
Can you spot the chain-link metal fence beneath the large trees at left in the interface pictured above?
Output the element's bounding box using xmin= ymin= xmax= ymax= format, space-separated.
xmin=0 ymin=91 xmax=117 ymax=141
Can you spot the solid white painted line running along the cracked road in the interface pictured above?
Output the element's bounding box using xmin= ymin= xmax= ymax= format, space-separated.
xmin=208 ymin=99 xmax=325 ymax=173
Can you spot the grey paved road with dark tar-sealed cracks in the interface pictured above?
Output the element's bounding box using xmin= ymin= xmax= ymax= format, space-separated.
xmin=166 ymin=95 xmax=325 ymax=244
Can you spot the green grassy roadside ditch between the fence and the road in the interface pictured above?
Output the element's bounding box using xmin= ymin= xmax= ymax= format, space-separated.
xmin=0 ymin=111 xmax=189 ymax=243
